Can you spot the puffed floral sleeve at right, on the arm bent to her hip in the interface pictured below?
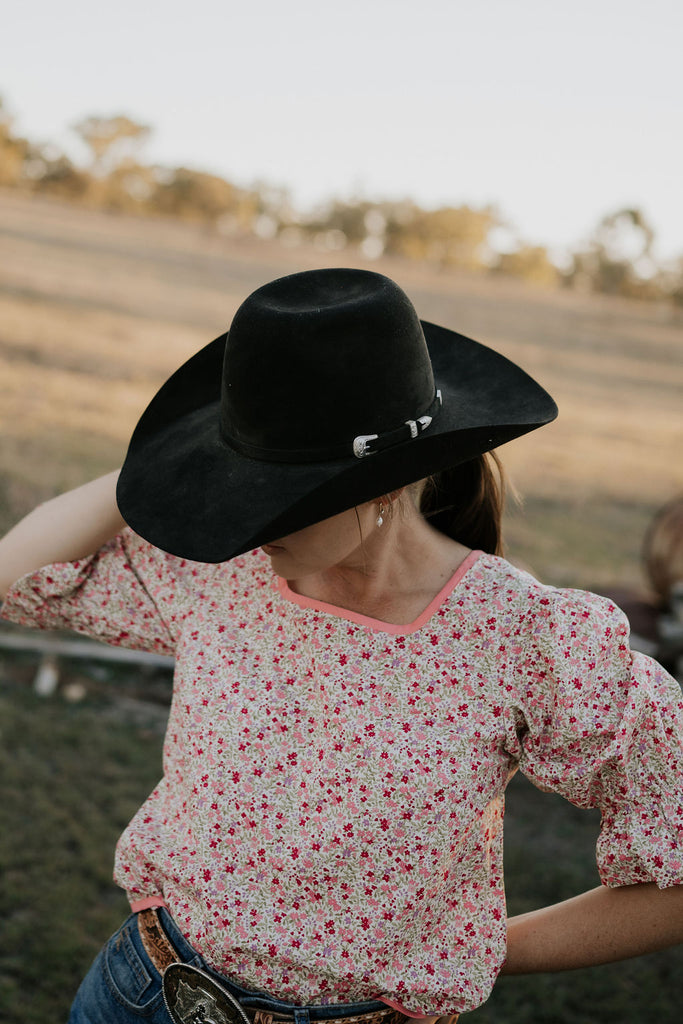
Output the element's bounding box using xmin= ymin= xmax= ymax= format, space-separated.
xmin=506 ymin=590 xmax=683 ymax=888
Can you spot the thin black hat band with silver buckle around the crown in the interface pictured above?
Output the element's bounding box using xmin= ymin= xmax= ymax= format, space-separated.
xmin=221 ymin=390 xmax=443 ymax=463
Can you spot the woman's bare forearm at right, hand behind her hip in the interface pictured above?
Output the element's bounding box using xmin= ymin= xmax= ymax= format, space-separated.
xmin=502 ymin=883 xmax=683 ymax=974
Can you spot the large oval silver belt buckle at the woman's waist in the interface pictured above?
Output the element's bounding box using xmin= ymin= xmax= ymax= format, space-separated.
xmin=163 ymin=964 xmax=251 ymax=1024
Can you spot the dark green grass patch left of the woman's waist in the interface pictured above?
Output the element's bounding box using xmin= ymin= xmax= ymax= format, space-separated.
xmin=0 ymin=671 xmax=162 ymax=1024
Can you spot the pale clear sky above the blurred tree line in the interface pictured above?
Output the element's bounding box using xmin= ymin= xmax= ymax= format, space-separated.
xmin=0 ymin=0 xmax=683 ymax=259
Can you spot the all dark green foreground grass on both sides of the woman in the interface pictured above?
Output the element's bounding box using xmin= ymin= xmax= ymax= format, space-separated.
xmin=0 ymin=656 xmax=683 ymax=1024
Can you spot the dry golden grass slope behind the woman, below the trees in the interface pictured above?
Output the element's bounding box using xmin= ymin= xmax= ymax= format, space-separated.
xmin=0 ymin=194 xmax=683 ymax=586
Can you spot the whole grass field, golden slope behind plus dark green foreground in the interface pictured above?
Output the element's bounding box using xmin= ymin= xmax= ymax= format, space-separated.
xmin=0 ymin=193 xmax=683 ymax=1024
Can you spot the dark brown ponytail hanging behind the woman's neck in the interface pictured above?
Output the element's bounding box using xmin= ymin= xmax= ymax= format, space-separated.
xmin=420 ymin=452 xmax=505 ymax=555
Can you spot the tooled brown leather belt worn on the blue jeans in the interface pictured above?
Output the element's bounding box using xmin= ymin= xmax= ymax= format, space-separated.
xmin=137 ymin=907 xmax=409 ymax=1024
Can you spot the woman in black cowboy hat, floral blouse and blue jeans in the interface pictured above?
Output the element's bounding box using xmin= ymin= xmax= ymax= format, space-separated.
xmin=0 ymin=270 xmax=683 ymax=1024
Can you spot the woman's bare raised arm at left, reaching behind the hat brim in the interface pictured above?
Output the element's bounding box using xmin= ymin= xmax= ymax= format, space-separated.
xmin=0 ymin=470 xmax=125 ymax=598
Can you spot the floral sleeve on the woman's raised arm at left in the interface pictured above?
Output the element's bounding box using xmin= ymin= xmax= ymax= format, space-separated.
xmin=2 ymin=528 xmax=199 ymax=655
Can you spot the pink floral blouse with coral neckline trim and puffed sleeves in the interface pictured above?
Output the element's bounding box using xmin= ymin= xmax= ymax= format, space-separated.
xmin=2 ymin=529 xmax=683 ymax=1015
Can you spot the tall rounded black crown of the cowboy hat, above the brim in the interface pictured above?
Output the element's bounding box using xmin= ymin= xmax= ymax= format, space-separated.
xmin=221 ymin=269 xmax=434 ymax=453
